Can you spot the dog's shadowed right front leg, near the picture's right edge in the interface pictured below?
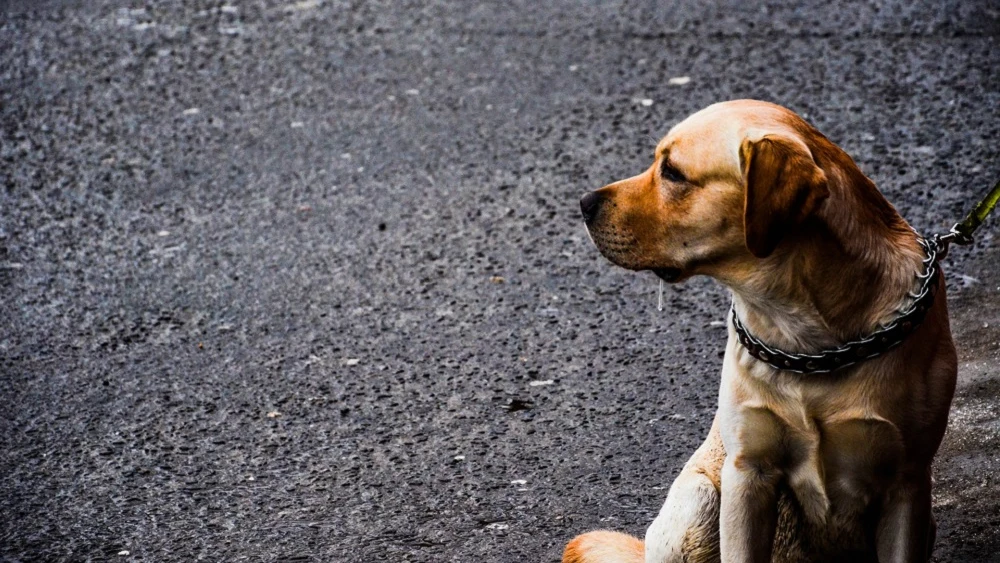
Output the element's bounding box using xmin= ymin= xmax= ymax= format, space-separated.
xmin=876 ymin=470 xmax=934 ymax=563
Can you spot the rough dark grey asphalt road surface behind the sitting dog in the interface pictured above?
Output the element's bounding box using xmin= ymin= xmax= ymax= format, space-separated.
xmin=0 ymin=0 xmax=1000 ymax=563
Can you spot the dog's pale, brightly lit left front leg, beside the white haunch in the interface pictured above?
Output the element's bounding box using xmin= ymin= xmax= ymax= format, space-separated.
xmin=719 ymin=454 xmax=780 ymax=563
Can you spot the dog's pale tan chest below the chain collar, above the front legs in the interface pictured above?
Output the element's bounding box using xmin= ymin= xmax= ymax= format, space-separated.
xmin=720 ymin=348 xmax=905 ymax=536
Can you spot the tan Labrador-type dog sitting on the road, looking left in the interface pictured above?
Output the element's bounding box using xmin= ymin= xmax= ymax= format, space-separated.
xmin=563 ymin=100 xmax=957 ymax=563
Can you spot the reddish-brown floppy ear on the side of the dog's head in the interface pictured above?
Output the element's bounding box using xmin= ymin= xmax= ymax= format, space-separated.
xmin=740 ymin=135 xmax=830 ymax=258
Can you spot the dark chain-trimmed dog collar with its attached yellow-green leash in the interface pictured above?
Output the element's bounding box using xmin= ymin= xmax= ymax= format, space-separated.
xmin=731 ymin=181 xmax=1000 ymax=374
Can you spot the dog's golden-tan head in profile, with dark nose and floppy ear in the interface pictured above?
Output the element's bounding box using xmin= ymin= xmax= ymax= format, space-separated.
xmin=580 ymin=100 xmax=830 ymax=281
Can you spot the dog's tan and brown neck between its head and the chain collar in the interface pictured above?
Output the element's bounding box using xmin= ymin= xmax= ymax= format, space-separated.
xmin=723 ymin=149 xmax=923 ymax=353
